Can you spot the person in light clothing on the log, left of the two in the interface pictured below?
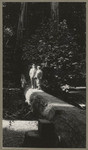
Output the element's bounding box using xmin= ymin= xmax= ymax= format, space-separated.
xmin=29 ymin=64 xmax=36 ymax=89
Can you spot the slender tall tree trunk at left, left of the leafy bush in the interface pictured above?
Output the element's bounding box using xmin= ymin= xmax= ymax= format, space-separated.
xmin=14 ymin=2 xmax=27 ymax=86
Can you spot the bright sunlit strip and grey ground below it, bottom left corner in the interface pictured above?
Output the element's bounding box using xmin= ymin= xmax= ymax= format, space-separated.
xmin=2 ymin=120 xmax=38 ymax=147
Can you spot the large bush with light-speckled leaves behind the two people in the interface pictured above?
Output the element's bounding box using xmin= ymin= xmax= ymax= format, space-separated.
xmin=22 ymin=19 xmax=85 ymax=90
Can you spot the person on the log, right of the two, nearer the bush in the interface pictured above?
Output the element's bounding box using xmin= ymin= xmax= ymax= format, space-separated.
xmin=35 ymin=66 xmax=43 ymax=90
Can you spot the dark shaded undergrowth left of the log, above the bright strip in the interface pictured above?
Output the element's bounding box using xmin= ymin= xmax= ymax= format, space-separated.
xmin=3 ymin=88 xmax=36 ymax=120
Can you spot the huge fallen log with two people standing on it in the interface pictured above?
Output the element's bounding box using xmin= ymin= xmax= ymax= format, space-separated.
xmin=25 ymin=89 xmax=86 ymax=148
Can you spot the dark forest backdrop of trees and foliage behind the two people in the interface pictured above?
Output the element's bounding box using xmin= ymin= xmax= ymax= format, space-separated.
xmin=3 ymin=2 xmax=86 ymax=90
